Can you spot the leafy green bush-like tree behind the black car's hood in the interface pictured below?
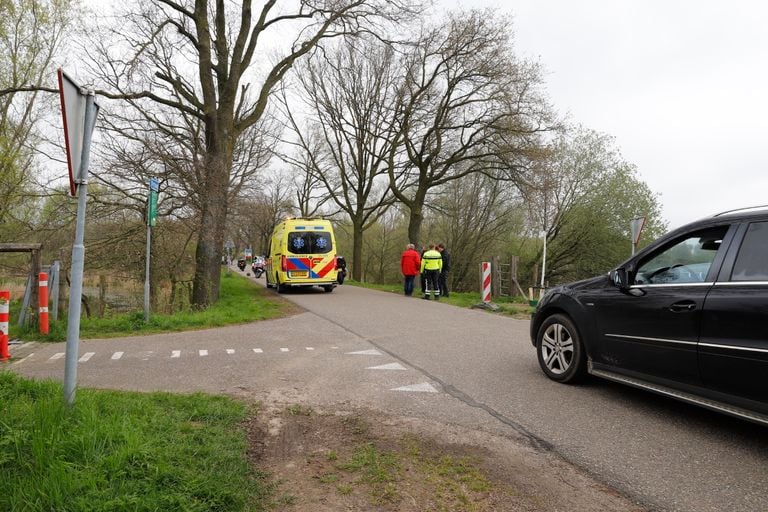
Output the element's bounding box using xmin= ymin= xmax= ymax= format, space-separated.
xmin=526 ymin=127 xmax=665 ymax=285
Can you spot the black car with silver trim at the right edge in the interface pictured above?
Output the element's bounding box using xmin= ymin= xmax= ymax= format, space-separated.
xmin=531 ymin=206 xmax=768 ymax=425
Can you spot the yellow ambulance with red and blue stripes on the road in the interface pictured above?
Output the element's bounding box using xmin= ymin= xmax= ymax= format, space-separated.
xmin=266 ymin=219 xmax=337 ymax=293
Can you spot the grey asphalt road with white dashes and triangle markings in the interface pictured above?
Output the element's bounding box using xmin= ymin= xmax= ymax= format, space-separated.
xmin=6 ymin=279 xmax=768 ymax=512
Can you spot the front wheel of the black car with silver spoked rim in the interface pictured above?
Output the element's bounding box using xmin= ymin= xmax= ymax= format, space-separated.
xmin=536 ymin=314 xmax=587 ymax=384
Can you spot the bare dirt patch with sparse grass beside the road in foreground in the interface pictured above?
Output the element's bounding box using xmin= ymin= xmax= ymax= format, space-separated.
xmin=247 ymin=403 xmax=644 ymax=512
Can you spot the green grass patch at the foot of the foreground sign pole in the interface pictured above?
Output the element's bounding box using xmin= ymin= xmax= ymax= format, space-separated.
xmin=0 ymin=372 xmax=274 ymax=512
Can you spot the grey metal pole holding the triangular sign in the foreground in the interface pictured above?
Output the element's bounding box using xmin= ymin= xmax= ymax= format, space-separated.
xmin=64 ymin=92 xmax=96 ymax=406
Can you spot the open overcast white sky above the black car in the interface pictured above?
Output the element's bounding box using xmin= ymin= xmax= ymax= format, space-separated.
xmin=439 ymin=0 xmax=768 ymax=228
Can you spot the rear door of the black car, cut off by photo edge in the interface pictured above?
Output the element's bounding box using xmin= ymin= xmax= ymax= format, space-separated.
xmin=698 ymin=221 xmax=768 ymax=404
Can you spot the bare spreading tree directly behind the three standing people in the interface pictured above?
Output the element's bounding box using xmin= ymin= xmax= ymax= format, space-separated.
xmin=389 ymin=11 xmax=550 ymax=246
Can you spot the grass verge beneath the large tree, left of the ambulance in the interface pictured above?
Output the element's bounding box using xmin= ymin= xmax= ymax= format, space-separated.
xmin=10 ymin=272 xmax=285 ymax=341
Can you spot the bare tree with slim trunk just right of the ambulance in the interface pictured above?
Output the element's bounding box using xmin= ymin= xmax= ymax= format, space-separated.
xmin=284 ymin=38 xmax=396 ymax=280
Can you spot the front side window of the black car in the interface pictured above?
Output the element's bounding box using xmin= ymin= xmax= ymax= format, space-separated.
xmin=634 ymin=226 xmax=728 ymax=285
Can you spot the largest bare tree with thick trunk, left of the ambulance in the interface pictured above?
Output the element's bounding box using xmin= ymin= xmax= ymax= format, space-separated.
xmin=80 ymin=0 xmax=420 ymax=307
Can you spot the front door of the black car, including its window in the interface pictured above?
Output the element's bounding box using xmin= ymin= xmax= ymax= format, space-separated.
xmin=591 ymin=225 xmax=729 ymax=385
